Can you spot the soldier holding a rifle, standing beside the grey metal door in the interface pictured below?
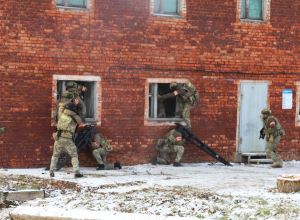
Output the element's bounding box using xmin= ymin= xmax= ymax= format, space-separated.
xmin=261 ymin=109 xmax=285 ymax=168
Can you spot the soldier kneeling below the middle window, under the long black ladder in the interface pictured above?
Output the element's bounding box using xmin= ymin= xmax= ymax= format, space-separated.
xmin=151 ymin=129 xmax=186 ymax=167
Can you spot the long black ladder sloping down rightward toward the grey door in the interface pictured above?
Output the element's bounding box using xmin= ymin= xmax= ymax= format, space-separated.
xmin=175 ymin=123 xmax=232 ymax=166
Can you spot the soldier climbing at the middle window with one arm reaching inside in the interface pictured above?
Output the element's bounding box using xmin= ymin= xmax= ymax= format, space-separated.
xmin=157 ymin=82 xmax=200 ymax=130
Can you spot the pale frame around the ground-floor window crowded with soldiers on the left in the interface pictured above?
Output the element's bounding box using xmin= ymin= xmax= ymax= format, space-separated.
xmin=51 ymin=75 xmax=102 ymax=126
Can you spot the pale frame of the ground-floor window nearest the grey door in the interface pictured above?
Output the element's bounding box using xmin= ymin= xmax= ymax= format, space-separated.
xmin=144 ymin=78 xmax=189 ymax=126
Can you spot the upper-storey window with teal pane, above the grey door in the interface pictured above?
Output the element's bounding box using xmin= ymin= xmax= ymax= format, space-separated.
xmin=241 ymin=0 xmax=263 ymax=20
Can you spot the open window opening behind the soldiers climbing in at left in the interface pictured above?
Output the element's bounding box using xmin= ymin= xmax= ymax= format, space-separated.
xmin=57 ymin=80 xmax=97 ymax=122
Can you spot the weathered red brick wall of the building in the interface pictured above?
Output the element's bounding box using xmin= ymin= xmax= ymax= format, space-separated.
xmin=0 ymin=0 xmax=300 ymax=167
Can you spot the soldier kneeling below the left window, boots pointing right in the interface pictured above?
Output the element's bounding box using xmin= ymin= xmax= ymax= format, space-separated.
xmin=88 ymin=131 xmax=122 ymax=170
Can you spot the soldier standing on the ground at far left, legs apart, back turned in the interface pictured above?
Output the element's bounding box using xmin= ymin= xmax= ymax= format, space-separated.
xmin=50 ymin=102 xmax=83 ymax=177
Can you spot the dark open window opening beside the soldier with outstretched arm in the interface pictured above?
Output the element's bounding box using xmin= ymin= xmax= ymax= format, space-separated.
xmin=148 ymin=83 xmax=181 ymax=121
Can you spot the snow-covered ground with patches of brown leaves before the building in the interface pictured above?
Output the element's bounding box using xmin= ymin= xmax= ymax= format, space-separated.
xmin=0 ymin=161 xmax=300 ymax=220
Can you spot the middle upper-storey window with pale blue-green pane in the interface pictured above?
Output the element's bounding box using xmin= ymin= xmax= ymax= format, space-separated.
xmin=154 ymin=0 xmax=181 ymax=15
